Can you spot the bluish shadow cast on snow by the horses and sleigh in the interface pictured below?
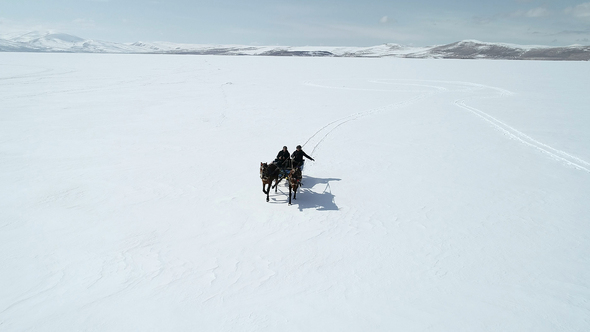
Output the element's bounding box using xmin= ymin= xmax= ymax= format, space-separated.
xmin=271 ymin=175 xmax=340 ymax=211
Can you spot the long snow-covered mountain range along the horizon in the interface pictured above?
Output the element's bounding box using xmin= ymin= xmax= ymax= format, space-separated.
xmin=0 ymin=32 xmax=590 ymax=61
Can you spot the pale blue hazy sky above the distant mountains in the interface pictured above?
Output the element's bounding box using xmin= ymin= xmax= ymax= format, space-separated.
xmin=0 ymin=0 xmax=590 ymax=46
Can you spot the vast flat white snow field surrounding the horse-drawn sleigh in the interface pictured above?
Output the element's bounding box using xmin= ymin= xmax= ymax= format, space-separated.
xmin=0 ymin=53 xmax=590 ymax=332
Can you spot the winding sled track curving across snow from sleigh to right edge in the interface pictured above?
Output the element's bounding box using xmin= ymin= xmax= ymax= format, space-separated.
xmin=303 ymin=79 xmax=590 ymax=173
